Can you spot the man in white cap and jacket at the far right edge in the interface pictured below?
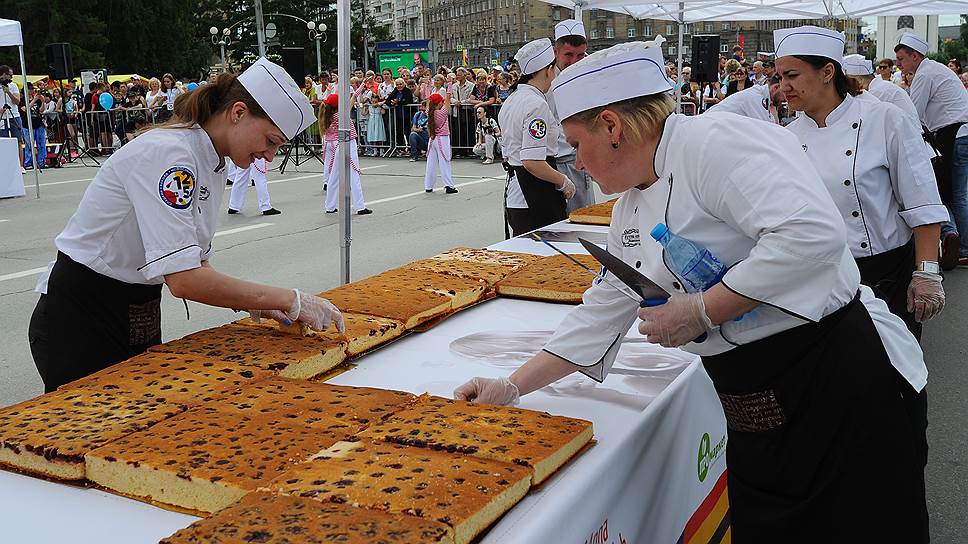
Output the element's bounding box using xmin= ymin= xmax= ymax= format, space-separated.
xmin=894 ymin=32 xmax=968 ymax=270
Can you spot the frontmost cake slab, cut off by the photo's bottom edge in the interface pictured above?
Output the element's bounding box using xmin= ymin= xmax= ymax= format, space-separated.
xmin=159 ymin=493 xmax=453 ymax=544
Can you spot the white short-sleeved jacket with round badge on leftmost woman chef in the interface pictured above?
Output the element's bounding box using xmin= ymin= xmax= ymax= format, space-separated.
xmin=36 ymin=125 xmax=225 ymax=293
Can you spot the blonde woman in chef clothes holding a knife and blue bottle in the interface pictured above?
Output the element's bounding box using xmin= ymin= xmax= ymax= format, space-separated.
xmin=454 ymin=37 xmax=927 ymax=543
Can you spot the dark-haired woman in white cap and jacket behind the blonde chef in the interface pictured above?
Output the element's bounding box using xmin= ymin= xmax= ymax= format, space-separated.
xmin=774 ymin=26 xmax=948 ymax=338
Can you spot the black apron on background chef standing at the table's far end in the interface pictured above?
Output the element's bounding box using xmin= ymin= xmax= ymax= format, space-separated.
xmin=504 ymin=157 xmax=568 ymax=236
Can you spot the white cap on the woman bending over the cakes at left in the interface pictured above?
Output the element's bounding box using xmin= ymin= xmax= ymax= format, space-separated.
xmin=239 ymin=57 xmax=316 ymax=139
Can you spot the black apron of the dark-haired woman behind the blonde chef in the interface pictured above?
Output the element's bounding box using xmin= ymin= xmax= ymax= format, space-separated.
xmin=856 ymin=238 xmax=921 ymax=342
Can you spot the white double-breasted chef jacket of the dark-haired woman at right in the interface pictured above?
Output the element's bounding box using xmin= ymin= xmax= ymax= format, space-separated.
xmin=787 ymin=95 xmax=948 ymax=258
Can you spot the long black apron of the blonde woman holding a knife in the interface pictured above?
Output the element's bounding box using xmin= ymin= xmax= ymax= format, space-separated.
xmin=702 ymin=297 xmax=928 ymax=544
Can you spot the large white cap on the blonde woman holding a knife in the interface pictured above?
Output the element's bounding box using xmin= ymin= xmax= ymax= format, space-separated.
xmin=551 ymin=36 xmax=673 ymax=120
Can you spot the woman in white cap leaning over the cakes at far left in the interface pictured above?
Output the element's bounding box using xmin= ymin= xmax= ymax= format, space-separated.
xmin=29 ymin=58 xmax=343 ymax=392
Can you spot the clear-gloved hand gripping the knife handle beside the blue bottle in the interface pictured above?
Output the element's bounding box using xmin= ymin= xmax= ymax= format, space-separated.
xmin=639 ymin=293 xmax=713 ymax=348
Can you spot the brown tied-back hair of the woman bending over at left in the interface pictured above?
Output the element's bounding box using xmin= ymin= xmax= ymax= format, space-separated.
xmin=161 ymin=74 xmax=269 ymax=128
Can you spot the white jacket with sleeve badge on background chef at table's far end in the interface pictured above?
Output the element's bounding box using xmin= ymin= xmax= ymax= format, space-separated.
xmin=497 ymin=83 xmax=561 ymax=209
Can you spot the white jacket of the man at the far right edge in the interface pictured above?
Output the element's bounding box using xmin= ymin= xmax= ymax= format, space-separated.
xmin=908 ymin=59 xmax=968 ymax=138
